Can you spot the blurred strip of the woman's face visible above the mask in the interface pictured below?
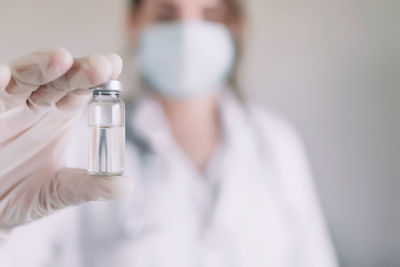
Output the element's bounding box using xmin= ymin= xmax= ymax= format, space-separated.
xmin=129 ymin=0 xmax=228 ymax=37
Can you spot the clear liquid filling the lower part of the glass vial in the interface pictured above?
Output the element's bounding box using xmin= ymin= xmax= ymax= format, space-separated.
xmin=88 ymin=125 xmax=125 ymax=176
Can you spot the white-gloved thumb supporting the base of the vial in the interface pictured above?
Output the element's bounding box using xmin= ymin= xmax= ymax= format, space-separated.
xmin=53 ymin=168 xmax=133 ymax=208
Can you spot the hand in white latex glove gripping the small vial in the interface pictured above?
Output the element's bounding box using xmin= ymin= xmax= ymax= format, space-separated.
xmin=0 ymin=48 xmax=132 ymax=239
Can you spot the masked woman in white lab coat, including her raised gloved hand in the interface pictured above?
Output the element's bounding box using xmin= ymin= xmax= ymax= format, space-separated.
xmin=0 ymin=0 xmax=336 ymax=267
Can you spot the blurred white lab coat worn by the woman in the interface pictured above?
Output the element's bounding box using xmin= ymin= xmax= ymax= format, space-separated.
xmin=0 ymin=92 xmax=337 ymax=267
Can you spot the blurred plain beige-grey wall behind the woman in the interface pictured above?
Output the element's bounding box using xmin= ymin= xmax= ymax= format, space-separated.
xmin=0 ymin=0 xmax=400 ymax=267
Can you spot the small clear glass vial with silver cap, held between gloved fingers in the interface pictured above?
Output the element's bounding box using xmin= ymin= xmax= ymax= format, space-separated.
xmin=88 ymin=80 xmax=125 ymax=176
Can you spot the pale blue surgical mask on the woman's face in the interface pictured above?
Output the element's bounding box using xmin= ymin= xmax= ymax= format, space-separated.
xmin=137 ymin=21 xmax=235 ymax=98
